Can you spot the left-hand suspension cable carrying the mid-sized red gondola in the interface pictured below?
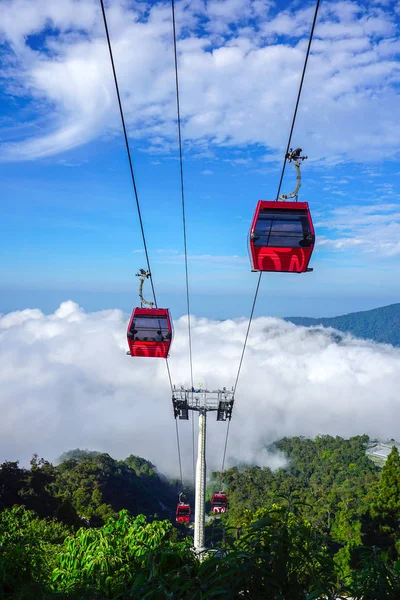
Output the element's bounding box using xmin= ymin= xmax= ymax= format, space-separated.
xmin=100 ymin=0 xmax=182 ymax=474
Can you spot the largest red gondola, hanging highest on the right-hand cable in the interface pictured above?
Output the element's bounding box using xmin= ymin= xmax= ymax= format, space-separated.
xmin=250 ymin=200 xmax=315 ymax=273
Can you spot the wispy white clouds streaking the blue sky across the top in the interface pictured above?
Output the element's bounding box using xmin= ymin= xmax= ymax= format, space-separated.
xmin=0 ymin=0 xmax=400 ymax=162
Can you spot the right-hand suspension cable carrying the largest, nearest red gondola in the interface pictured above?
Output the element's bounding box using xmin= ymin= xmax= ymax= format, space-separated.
xmin=221 ymin=0 xmax=320 ymax=479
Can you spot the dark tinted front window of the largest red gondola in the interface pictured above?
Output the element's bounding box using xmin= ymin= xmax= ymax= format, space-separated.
xmin=252 ymin=210 xmax=312 ymax=248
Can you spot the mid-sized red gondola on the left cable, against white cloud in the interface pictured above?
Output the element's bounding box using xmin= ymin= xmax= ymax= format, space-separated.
xmin=127 ymin=308 xmax=172 ymax=358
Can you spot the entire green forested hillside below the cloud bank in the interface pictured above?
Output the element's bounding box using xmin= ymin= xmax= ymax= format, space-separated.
xmin=0 ymin=435 xmax=400 ymax=600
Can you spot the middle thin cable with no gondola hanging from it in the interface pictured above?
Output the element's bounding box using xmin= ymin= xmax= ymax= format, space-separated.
xmin=171 ymin=0 xmax=195 ymax=487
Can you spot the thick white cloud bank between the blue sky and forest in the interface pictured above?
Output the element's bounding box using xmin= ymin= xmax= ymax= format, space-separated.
xmin=0 ymin=302 xmax=400 ymax=478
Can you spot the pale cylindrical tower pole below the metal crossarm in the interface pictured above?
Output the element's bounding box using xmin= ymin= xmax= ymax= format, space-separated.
xmin=194 ymin=410 xmax=207 ymax=552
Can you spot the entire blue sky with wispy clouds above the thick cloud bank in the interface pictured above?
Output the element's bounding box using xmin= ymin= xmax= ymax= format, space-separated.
xmin=0 ymin=0 xmax=400 ymax=319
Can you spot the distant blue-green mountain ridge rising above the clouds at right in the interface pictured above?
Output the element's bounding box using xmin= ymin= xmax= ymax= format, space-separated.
xmin=285 ymin=303 xmax=400 ymax=346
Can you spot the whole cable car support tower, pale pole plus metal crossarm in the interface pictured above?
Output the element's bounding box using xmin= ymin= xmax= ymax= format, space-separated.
xmin=172 ymin=387 xmax=234 ymax=552
